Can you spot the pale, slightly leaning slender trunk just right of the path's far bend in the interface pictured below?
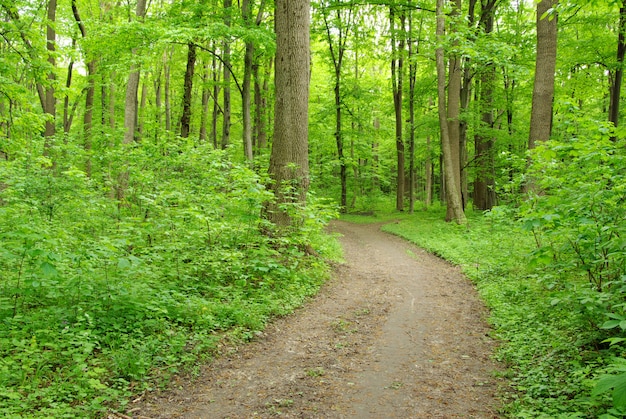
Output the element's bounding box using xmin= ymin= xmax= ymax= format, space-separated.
xmin=436 ymin=0 xmax=467 ymax=224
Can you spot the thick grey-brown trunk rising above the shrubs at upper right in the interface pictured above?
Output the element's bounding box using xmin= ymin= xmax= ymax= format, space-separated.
xmin=528 ymin=0 xmax=558 ymax=149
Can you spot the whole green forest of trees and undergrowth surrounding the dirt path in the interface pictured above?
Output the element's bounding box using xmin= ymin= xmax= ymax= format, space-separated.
xmin=0 ymin=0 xmax=626 ymax=419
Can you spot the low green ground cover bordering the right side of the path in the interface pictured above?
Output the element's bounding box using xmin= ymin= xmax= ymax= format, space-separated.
xmin=342 ymin=207 xmax=626 ymax=418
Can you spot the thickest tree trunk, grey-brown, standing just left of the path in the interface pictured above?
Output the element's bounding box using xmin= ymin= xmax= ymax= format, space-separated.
xmin=267 ymin=0 xmax=310 ymax=226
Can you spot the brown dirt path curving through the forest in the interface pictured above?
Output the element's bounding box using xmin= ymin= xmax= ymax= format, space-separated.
xmin=130 ymin=222 xmax=498 ymax=419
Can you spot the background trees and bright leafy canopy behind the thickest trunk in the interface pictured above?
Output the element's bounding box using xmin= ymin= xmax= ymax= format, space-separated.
xmin=0 ymin=0 xmax=626 ymax=220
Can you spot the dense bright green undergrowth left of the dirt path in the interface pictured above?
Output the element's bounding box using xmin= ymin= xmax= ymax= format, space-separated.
xmin=0 ymin=146 xmax=338 ymax=418
